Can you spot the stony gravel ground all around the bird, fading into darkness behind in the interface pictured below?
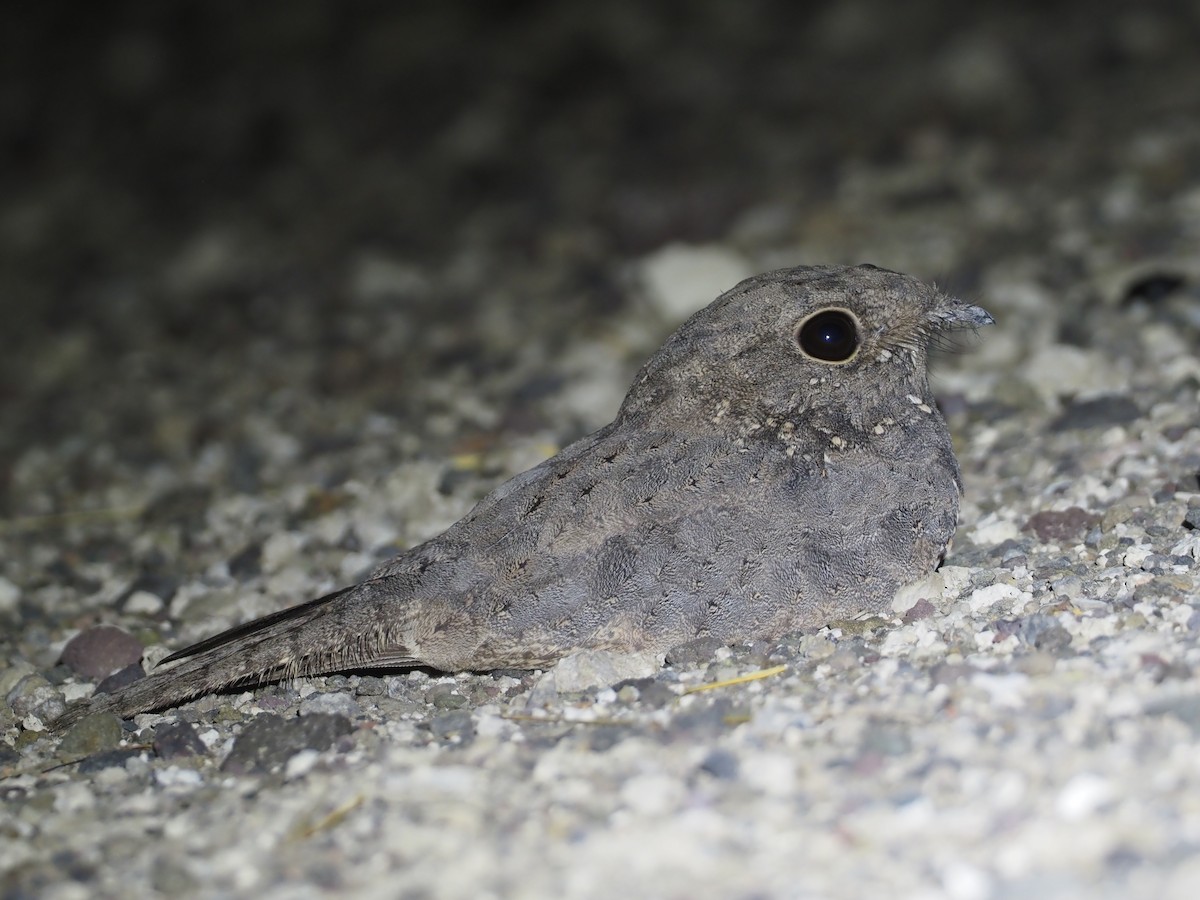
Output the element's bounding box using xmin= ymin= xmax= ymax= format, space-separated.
xmin=0 ymin=0 xmax=1200 ymax=900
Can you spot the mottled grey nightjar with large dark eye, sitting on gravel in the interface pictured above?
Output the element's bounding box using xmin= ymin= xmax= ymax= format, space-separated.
xmin=58 ymin=266 xmax=991 ymax=718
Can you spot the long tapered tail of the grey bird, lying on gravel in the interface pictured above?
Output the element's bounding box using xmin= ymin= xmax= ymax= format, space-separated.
xmin=54 ymin=578 xmax=419 ymax=730
